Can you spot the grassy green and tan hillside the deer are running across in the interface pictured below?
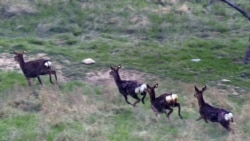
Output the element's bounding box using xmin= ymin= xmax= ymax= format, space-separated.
xmin=0 ymin=0 xmax=250 ymax=141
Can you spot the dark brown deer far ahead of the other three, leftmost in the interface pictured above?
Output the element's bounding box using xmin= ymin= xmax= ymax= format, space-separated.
xmin=13 ymin=51 xmax=57 ymax=86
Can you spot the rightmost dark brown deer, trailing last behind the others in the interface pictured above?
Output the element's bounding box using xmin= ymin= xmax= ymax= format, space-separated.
xmin=194 ymin=86 xmax=234 ymax=133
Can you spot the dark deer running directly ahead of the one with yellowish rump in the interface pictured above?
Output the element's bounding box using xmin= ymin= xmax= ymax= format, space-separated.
xmin=110 ymin=65 xmax=147 ymax=107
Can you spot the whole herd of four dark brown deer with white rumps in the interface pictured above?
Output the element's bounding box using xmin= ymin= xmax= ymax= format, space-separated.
xmin=12 ymin=51 xmax=234 ymax=133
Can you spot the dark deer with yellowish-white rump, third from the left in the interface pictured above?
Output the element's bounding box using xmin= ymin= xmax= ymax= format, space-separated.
xmin=146 ymin=83 xmax=182 ymax=119
